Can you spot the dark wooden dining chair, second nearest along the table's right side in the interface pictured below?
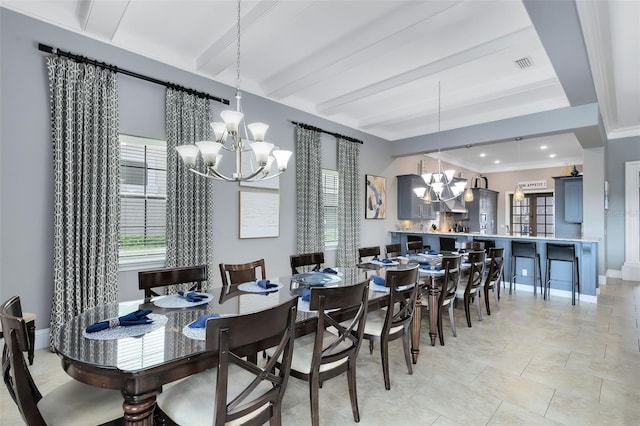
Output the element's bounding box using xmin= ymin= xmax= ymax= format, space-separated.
xmin=267 ymin=280 xmax=369 ymax=426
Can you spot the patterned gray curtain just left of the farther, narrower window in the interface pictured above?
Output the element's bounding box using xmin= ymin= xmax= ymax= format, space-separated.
xmin=296 ymin=125 xmax=324 ymax=253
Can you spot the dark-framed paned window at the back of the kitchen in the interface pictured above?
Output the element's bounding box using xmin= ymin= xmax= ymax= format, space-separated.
xmin=510 ymin=192 xmax=554 ymax=237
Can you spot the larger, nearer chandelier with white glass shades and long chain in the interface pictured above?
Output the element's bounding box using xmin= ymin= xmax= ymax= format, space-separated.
xmin=176 ymin=0 xmax=292 ymax=182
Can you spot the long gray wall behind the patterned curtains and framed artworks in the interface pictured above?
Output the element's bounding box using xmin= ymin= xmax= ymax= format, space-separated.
xmin=0 ymin=8 xmax=395 ymax=329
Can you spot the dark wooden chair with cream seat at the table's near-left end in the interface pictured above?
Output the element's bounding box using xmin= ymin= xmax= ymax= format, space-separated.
xmin=0 ymin=296 xmax=124 ymax=426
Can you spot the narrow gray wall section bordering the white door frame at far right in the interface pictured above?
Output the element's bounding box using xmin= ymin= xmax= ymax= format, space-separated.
xmin=605 ymin=136 xmax=640 ymax=271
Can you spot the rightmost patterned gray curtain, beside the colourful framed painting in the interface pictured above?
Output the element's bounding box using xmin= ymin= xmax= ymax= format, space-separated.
xmin=336 ymin=138 xmax=362 ymax=266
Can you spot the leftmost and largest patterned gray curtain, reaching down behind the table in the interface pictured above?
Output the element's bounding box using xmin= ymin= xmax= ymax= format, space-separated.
xmin=47 ymin=57 xmax=120 ymax=347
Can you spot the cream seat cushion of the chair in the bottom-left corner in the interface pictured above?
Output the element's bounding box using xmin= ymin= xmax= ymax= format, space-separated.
xmin=38 ymin=380 xmax=124 ymax=426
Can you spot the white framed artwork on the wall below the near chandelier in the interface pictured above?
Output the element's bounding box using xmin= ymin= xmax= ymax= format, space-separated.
xmin=240 ymin=191 xmax=280 ymax=238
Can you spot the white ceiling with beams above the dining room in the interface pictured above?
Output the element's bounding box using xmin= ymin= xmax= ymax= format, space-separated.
xmin=1 ymin=0 xmax=640 ymax=172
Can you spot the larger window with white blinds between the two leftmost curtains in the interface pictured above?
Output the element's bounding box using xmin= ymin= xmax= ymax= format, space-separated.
xmin=120 ymin=135 xmax=167 ymax=259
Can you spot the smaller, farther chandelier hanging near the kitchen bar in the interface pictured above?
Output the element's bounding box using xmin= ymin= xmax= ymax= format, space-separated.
xmin=413 ymin=82 xmax=473 ymax=204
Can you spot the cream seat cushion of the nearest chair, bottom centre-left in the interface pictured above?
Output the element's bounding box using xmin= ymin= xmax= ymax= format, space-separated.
xmin=157 ymin=364 xmax=271 ymax=426
